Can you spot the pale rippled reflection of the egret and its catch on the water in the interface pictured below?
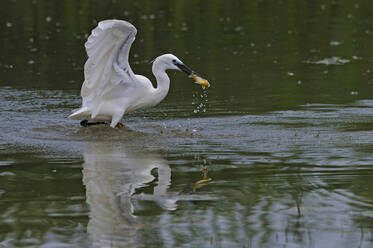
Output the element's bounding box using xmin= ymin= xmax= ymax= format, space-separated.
xmin=83 ymin=142 xmax=211 ymax=247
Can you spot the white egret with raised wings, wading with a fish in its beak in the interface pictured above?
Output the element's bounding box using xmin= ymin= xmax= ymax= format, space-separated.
xmin=68 ymin=20 xmax=209 ymax=128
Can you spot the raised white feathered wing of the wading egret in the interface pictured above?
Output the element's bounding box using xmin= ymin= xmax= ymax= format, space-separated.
xmin=81 ymin=20 xmax=137 ymax=106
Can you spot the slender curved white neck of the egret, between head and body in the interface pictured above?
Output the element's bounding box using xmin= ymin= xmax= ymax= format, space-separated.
xmin=152 ymin=59 xmax=170 ymax=102
